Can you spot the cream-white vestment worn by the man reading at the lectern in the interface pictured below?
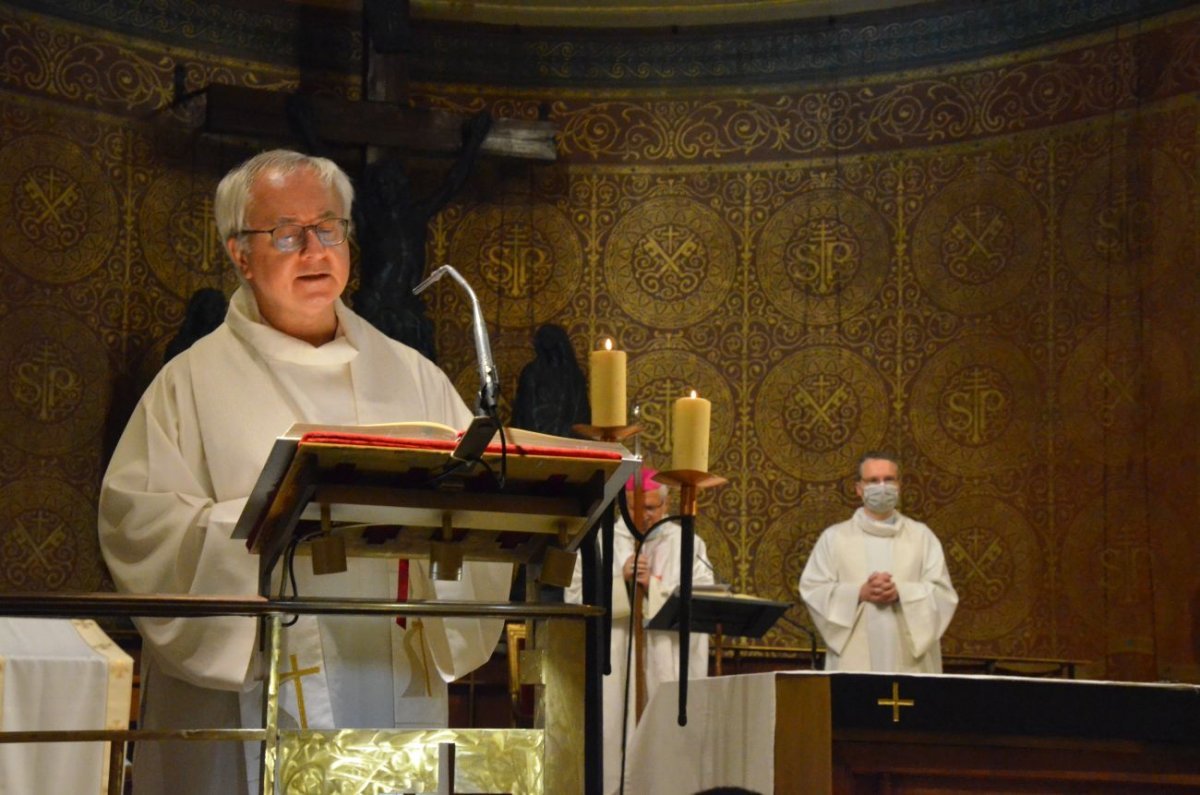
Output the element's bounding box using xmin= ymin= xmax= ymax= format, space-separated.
xmin=100 ymin=287 xmax=511 ymax=795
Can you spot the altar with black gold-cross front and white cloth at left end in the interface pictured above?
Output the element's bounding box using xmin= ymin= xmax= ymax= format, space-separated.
xmin=626 ymin=671 xmax=1200 ymax=795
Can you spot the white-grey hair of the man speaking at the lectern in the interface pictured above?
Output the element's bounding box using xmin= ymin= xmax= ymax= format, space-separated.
xmin=212 ymin=149 xmax=354 ymax=264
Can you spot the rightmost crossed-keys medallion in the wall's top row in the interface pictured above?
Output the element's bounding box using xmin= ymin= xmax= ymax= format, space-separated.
xmin=912 ymin=174 xmax=1043 ymax=315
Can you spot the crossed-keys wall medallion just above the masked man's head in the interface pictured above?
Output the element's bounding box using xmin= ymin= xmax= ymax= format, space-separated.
xmin=754 ymin=346 xmax=888 ymax=480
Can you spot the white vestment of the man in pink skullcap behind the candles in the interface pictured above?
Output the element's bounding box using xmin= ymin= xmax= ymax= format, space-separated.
xmin=565 ymin=519 xmax=713 ymax=795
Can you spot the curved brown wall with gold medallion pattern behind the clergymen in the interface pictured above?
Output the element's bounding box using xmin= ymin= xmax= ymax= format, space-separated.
xmin=0 ymin=1 xmax=1200 ymax=681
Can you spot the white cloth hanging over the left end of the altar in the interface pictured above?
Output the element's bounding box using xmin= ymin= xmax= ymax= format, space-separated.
xmin=625 ymin=671 xmax=780 ymax=795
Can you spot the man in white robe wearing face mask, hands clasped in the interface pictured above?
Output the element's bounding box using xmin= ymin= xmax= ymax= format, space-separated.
xmin=800 ymin=452 xmax=959 ymax=674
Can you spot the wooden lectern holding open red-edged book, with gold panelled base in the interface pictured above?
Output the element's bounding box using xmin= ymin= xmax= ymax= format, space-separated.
xmin=234 ymin=424 xmax=636 ymax=795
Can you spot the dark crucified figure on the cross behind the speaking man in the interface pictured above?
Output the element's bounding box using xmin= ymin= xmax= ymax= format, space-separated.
xmin=354 ymin=112 xmax=492 ymax=360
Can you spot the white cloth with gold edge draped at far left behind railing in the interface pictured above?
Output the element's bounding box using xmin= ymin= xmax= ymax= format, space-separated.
xmin=0 ymin=618 xmax=133 ymax=795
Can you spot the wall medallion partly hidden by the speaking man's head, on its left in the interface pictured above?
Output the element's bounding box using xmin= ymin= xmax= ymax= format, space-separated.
xmin=138 ymin=173 xmax=239 ymax=299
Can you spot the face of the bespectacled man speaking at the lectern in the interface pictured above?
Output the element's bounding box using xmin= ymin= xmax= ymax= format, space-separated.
xmin=227 ymin=168 xmax=350 ymax=345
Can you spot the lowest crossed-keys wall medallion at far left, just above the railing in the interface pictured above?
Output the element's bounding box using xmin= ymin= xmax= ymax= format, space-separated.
xmin=0 ymin=479 xmax=96 ymax=591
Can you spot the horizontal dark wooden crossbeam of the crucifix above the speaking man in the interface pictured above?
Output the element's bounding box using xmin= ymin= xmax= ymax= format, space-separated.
xmin=204 ymin=84 xmax=557 ymax=161
